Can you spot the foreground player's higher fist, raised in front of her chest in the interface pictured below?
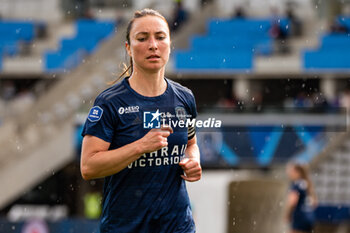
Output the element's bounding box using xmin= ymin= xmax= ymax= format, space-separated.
xmin=139 ymin=126 xmax=173 ymax=153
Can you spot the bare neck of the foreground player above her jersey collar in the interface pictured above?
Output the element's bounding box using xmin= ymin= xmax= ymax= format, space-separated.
xmin=129 ymin=66 xmax=167 ymax=97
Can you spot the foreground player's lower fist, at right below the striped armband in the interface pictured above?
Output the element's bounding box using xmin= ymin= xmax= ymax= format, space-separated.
xmin=179 ymin=158 xmax=202 ymax=182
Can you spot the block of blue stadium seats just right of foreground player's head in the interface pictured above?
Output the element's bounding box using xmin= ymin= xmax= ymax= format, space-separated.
xmin=175 ymin=19 xmax=289 ymax=72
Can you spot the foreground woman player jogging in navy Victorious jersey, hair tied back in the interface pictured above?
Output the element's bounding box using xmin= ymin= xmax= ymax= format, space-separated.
xmin=81 ymin=9 xmax=202 ymax=233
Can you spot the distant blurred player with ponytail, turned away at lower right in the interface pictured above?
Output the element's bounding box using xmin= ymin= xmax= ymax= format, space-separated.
xmin=287 ymin=163 xmax=317 ymax=233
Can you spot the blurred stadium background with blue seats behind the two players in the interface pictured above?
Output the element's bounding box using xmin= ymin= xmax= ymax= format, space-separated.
xmin=0 ymin=0 xmax=350 ymax=233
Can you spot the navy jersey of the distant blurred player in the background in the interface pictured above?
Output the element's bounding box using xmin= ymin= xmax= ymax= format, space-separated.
xmin=290 ymin=180 xmax=314 ymax=232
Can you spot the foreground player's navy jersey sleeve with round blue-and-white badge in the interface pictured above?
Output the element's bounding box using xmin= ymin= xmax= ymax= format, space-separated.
xmin=82 ymin=97 xmax=116 ymax=143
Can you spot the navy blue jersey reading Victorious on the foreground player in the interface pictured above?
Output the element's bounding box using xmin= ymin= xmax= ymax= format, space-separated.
xmin=82 ymin=78 xmax=197 ymax=233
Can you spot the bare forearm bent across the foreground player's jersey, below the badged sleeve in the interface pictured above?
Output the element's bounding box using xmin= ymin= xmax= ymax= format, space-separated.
xmin=81 ymin=141 xmax=143 ymax=180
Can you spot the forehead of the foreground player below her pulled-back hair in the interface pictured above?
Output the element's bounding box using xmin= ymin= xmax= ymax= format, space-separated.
xmin=130 ymin=16 xmax=169 ymax=34
